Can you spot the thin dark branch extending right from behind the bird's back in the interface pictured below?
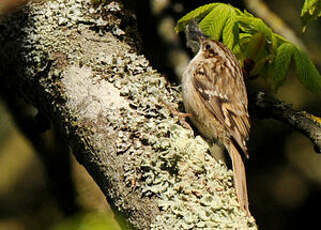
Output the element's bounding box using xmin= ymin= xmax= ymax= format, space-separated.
xmin=249 ymin=92 xmax=321 ymax=153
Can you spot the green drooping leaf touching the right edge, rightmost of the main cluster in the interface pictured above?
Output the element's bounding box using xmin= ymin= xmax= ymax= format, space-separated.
xmin=294 ymin=48 xmax=321 ymax=92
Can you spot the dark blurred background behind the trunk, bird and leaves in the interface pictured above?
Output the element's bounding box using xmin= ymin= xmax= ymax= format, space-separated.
xmin=0 ymin=0 xmax=321 ymax=230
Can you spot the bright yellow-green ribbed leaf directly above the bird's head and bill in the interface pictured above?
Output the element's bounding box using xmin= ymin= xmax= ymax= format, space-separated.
xmin=199 ymin=4 xmax=232 ymax=41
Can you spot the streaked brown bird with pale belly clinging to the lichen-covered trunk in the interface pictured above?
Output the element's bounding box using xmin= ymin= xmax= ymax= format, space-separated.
xmin=182 ymin=21 xmax=250 ymax=214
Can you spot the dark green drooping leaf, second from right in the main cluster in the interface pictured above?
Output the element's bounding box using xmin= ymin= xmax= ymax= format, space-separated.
xmin=268 ymin=43 xmax=296 ymax=90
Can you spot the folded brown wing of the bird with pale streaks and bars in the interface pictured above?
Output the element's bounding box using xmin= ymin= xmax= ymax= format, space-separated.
xmin=193 ymin=58 xmax=250 ymax=157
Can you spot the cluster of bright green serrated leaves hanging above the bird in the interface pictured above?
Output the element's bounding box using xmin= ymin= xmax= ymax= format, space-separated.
xmin=175 ymin=3 xmax=321 ymax=91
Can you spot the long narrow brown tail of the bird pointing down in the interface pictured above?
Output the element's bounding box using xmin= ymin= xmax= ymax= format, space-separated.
xmin=228 ymin=141 xmax=251 ymax=215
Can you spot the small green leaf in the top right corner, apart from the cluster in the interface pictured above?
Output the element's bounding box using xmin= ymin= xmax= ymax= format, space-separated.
xmin=301 ymin=0 xmax=321 ymax=32
